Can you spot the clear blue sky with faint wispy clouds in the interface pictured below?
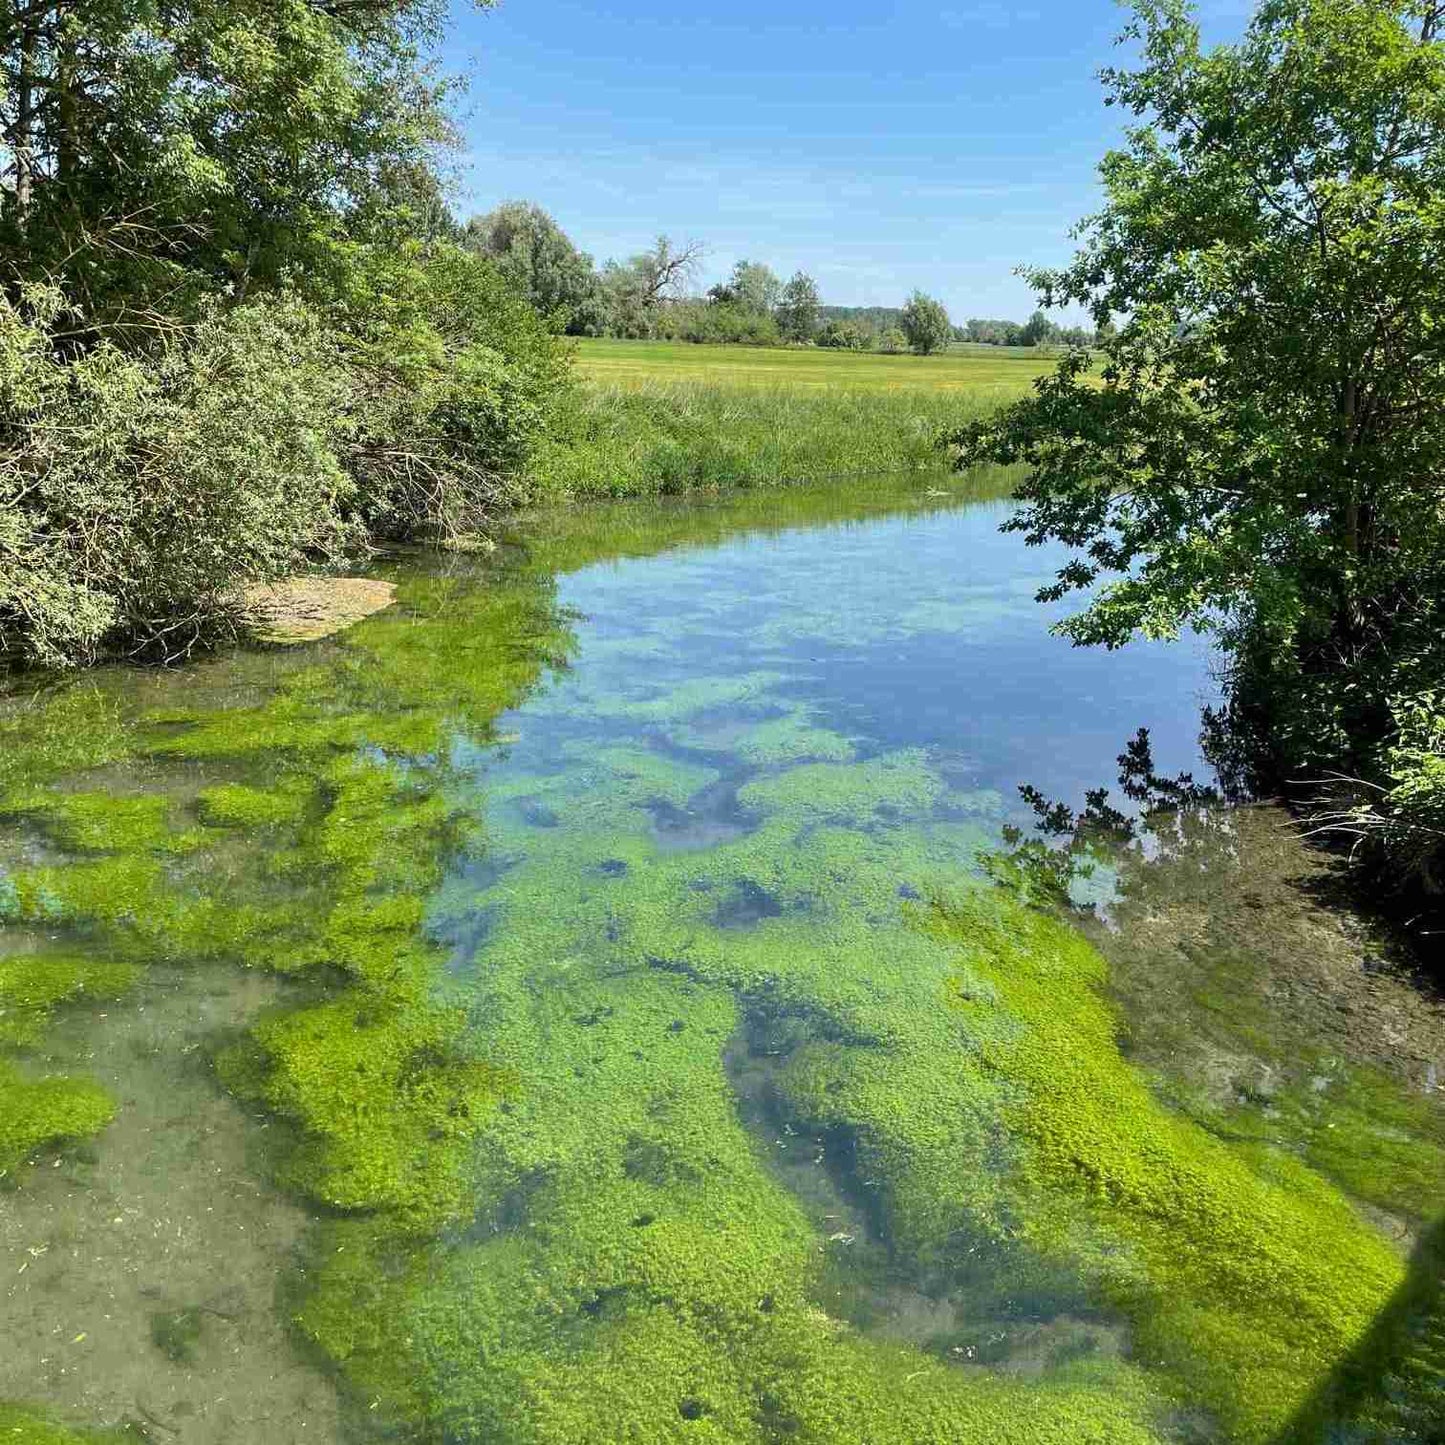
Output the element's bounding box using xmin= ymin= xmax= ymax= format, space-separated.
xmin=445 ymin=0 xmax=1248 ymax=318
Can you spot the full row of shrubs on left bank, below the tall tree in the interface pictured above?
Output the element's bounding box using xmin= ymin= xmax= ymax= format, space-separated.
xmin=0 ymin=244 xmax=568 ymax=666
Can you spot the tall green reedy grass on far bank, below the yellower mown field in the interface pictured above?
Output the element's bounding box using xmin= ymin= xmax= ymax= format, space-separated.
xmin=530 ymin=380 xmax=1028 ymax=500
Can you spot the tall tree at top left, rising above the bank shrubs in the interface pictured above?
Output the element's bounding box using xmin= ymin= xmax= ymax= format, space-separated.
xmin=0 ymin=0 xmax=473 ymax=327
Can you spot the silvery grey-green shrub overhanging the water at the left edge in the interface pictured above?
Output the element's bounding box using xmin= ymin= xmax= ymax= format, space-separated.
xmin=0 ymin=288 xmax=357 ymax=665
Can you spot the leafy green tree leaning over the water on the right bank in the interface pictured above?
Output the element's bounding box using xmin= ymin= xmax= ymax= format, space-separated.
xmin=954 ymin=0 xmax=1445 ymax=767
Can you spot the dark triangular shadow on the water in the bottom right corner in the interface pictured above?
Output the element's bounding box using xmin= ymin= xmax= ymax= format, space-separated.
xmin=1274 ymin=1215 xmax=1445 ymax=1445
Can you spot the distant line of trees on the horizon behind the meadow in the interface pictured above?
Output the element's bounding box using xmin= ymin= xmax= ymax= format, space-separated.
xmin=458 ymin=201 xmax=1098 ymax=354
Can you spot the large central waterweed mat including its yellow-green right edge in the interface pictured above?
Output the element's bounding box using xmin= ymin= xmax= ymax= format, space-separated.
xmin=301 ymin=670 xmax=1400 ymax=1442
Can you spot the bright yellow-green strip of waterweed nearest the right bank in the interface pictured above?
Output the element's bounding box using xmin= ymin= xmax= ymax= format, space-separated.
xmin=938 ymin=897 xmax=1403 ymax=1439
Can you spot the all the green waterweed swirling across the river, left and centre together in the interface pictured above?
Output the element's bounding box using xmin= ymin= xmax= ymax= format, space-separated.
xmin=0 ymin=482 xmax=1439 ymax=1445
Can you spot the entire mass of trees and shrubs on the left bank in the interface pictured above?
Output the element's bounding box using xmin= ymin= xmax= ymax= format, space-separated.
xmin=0 ymin=0 xmax=575 ymax=665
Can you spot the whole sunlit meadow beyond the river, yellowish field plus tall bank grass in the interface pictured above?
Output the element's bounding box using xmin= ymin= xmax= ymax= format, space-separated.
xmin=532 ymin=340 xmax=1053 ymax=501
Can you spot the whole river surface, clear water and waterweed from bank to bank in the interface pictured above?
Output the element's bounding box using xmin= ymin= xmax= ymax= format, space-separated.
xmin=0 ymin=480 xmax=1445 ymax=1445
